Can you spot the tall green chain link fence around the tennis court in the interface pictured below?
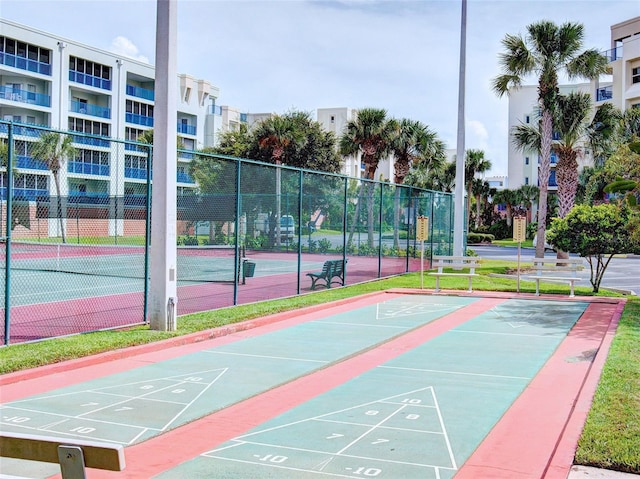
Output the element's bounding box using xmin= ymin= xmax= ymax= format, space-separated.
xmin=0 ymin=122 xmax=453 ymax=344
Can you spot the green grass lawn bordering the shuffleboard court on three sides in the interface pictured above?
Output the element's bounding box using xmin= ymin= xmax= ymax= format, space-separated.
xmin=0 ymin=261 xmax=640 ymax=473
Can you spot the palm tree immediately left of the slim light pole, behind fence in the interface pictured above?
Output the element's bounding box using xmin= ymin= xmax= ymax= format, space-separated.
xmin=391 ymin=119 xmax=445 ymax=248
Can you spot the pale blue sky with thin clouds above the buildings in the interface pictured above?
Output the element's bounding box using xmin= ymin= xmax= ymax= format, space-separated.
xmin=0 ymin=0 xmax=640 ymax=175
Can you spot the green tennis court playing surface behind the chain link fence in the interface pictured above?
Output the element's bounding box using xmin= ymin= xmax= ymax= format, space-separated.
xmin=3 ymin=241 xmax=323 ymax=306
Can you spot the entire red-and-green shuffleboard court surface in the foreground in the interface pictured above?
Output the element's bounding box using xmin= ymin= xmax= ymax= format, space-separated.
xmin=0 ymin=290 xmax=624 ymax=479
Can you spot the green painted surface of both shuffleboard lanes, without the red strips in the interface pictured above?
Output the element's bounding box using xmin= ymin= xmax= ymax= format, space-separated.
xmin=0 ymin=295 xmax=587 ymax=479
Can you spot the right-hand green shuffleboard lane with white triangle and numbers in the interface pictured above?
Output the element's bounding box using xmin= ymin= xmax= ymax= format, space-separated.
xmin=152 ymin=300 xmax=586 ymax=479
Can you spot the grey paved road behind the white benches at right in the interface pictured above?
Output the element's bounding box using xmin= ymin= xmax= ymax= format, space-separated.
xmin=469 ymin=245 xmax=640 ymax=295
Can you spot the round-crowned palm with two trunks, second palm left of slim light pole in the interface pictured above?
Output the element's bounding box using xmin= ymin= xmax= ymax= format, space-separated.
xmin=338 ymin=108 xmax=398 ymax=247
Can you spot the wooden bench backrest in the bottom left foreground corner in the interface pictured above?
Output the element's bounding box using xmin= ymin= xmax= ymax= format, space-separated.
xmin=0 ymin=432 xmax=125 ymax=479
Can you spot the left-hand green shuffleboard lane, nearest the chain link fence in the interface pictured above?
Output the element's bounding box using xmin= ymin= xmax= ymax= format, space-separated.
xmin=0 ymin=296 xmax=477 ymax=479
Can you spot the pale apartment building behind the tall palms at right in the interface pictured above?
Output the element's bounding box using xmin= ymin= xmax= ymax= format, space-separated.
xmin=508 ymin=17 xmax=640 ymax=192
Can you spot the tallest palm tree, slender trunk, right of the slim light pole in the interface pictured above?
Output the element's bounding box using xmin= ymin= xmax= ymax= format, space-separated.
xmin=493 ymin=20 xmax=607 ymax=258
